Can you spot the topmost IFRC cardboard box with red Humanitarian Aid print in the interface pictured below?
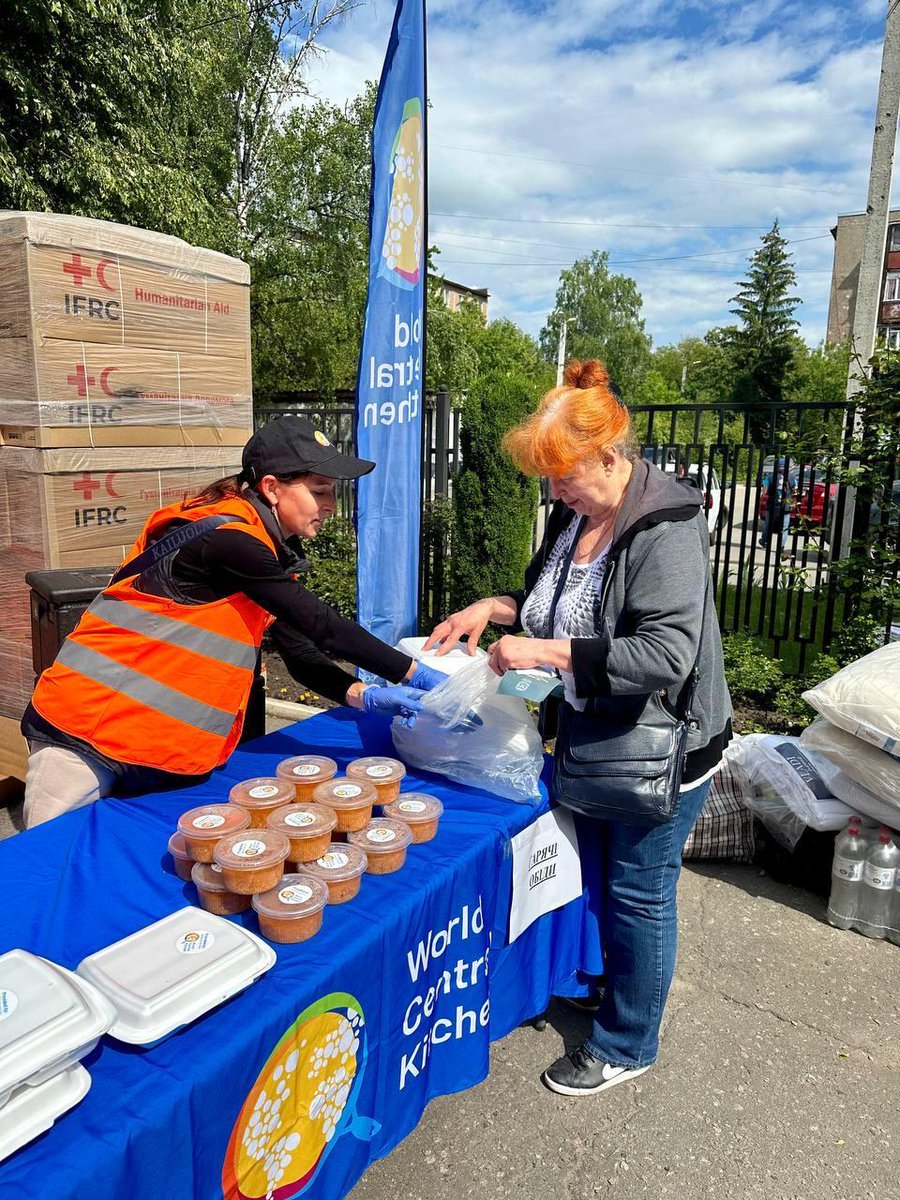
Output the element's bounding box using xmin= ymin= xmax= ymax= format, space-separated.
xmin=0 ymin=212 xmax=250 ymax=358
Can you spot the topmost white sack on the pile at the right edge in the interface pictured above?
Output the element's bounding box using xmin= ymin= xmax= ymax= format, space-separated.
xmin=803 ymin=642 xmax=900 ymax=755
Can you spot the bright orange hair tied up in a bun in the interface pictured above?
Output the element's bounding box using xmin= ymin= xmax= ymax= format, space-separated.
xmin=503 ymin=359 xmax=634 ymax=478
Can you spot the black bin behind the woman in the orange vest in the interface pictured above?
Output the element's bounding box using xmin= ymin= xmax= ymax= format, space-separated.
xmin=25 ymin=566 xmax=265 ymax=742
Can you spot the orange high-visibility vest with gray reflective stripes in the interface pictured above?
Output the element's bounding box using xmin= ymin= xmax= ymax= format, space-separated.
xmin=31 ymin=497 xmax=275 ymax=775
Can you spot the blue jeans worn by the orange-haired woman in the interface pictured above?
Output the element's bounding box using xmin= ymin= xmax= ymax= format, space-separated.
xmin=576 ymin=780 xmax=709 ymax=1067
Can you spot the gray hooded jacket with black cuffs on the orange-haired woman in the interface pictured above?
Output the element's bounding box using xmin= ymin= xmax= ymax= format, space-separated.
xmin=514 ymin=460 xmax=732 ymax=782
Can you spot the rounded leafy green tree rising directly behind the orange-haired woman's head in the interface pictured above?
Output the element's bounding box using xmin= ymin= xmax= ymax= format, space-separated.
xmin=540 ymin=250 xmax=650 ymax=402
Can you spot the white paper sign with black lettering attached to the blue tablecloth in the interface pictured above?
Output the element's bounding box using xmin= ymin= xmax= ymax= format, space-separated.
xmin=509 ymin=808 xmax=582 ymax=944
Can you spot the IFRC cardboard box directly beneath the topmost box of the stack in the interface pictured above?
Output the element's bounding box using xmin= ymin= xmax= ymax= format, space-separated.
xmin=0 ymin=337 xmax=253 ymax=446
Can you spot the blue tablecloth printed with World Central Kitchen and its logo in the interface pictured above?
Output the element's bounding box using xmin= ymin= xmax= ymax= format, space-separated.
xmin=0 ymin=709 xmax=600 ymax=1200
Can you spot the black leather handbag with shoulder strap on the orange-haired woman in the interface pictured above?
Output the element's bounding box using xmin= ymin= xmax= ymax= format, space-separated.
xmin=550 ymin=511 xmax=707 ymax=826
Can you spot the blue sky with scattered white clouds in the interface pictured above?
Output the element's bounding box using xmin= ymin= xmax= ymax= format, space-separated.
xmin=308 ymin=0 xmax=887 ymax=346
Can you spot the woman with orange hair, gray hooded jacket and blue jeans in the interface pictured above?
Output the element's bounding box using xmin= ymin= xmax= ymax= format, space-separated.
xmin=426 ymin=360 xmax=731 ymax=1096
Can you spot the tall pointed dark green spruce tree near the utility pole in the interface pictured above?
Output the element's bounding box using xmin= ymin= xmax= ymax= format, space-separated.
xmin=731 ymin=221 xmax=802 ymax=440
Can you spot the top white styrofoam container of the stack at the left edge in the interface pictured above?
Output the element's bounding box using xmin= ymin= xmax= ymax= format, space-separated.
xmin=0 ymin=949 xmax=116 ymax=1108
